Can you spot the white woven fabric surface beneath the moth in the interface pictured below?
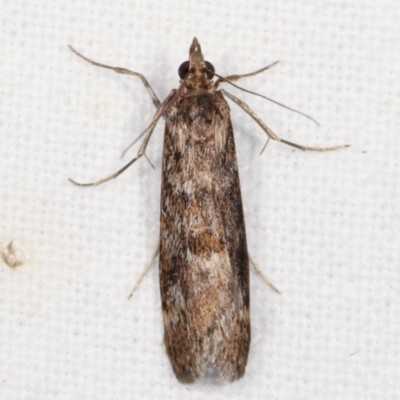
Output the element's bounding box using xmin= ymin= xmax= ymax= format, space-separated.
xmin=0 ymin=0 xmax=400 ymax=400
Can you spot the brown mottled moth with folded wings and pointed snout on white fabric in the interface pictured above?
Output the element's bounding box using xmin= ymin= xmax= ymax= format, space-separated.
xmin=71 ymin=38 xmax=346 ymax=384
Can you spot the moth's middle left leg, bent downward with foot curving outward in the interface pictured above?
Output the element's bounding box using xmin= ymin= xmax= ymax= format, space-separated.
xmin=68 ymin=90 xmax=176 ymax=187
